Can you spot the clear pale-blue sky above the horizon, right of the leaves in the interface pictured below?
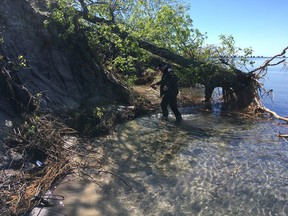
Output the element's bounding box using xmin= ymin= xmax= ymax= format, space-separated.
xmin=188 ymin=0 xmax=288 ymax=57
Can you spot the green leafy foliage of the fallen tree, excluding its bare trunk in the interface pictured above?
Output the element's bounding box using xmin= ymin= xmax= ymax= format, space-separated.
xmin=46 ymin=0 xmax=252 ymax=88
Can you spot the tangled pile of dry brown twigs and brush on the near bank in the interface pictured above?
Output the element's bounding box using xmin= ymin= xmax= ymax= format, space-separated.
xmin=0 ymin=115 xmax=127 ymax=216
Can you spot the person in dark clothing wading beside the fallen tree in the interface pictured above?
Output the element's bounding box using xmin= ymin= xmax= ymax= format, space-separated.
xmin=151 ymin=63 xmax=182 ymax=121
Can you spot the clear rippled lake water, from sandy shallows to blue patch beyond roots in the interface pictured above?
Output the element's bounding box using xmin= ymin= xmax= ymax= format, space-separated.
xmin=31 ymin=59 xmax=288 ymax=216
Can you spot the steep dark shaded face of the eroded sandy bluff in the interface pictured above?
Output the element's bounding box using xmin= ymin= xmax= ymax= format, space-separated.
xmin=0 ymin=0 xmax=129 ymax=126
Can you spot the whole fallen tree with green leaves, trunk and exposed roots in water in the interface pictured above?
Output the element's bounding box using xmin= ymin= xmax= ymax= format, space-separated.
xmin=45 ymin=0 xmax=288 ymax=120
